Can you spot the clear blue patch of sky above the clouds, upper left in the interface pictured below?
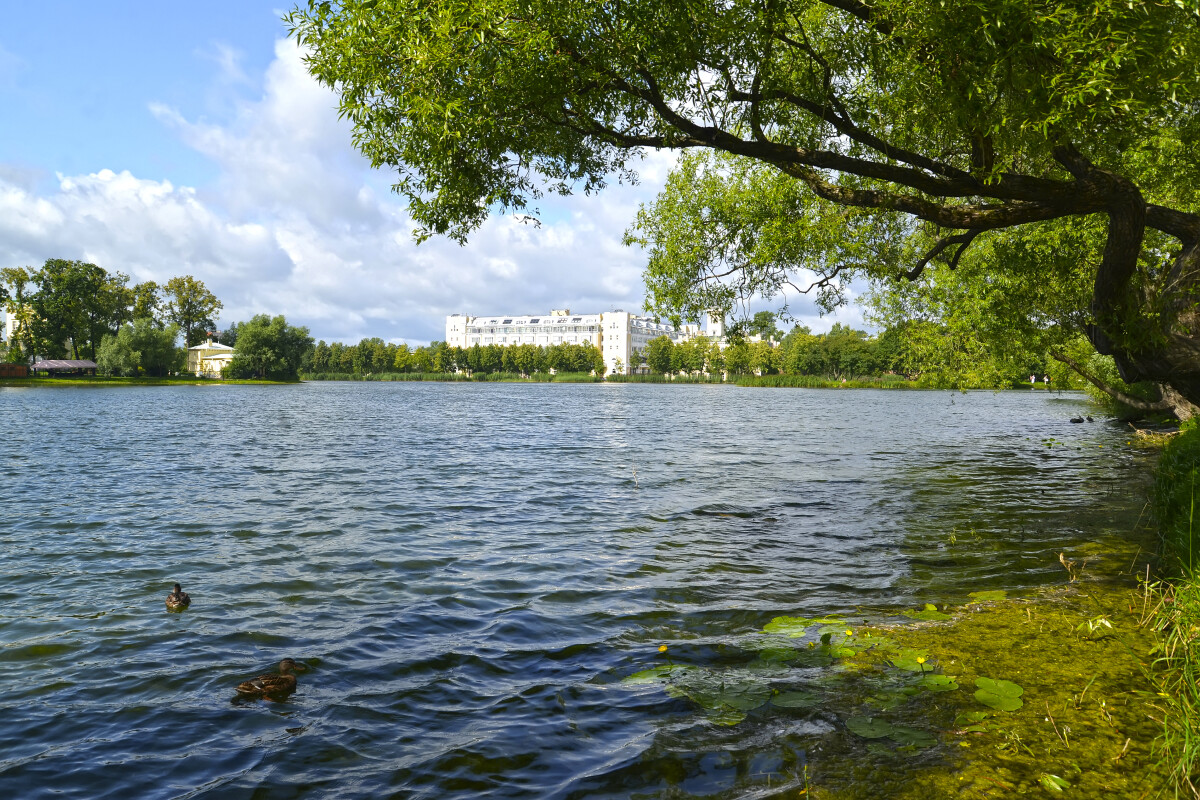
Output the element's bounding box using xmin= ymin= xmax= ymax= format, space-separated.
xmin=0 ymin=0 xmax=286 ymax=185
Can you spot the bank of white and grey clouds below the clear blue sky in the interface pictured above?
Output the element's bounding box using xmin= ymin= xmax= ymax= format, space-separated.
xmin=0 ymin=40 xmax=864 ymax=342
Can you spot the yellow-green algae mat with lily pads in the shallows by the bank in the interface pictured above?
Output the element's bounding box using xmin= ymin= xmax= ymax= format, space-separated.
xmin=630 ymin=542 xmax=1162 ymax=800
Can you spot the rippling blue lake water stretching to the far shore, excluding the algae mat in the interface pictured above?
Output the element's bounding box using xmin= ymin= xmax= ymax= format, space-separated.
xmin=0 ymin=384 xmax=1147 ymax=800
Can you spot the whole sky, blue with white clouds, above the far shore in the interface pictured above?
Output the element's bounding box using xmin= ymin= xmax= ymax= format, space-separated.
xmin=0 ymin=0 xmax=858 ymax=343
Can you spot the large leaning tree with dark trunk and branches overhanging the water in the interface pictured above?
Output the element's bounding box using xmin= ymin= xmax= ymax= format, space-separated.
xmin=289 ymin=0 xmax=1200 ymax=419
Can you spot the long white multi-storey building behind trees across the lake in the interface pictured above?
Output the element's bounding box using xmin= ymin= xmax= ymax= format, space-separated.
xmin=445 ymin=308 xmax=710 ymax=374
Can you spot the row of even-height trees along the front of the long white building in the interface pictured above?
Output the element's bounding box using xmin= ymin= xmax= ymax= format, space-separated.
xmin=304 ymin=338 xmax=605 ymax=375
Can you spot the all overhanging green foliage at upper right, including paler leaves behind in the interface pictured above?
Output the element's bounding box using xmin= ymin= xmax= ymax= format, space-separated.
xmin=288 ymin=0 xmax=1200 ymax=407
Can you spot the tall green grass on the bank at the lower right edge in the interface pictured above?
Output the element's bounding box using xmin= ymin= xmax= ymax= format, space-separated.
xmin=1147 ymin=422 xmax=1200 ymax=798
